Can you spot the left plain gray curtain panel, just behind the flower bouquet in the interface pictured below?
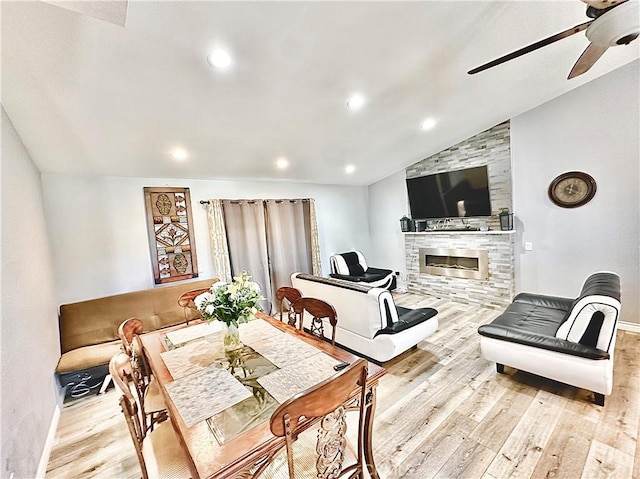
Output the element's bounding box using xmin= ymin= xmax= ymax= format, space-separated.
xmin=222 ymin=200 xmax=273 ymax=313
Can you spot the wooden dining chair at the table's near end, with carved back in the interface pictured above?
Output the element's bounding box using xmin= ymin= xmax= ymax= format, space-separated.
xmin=260 ymin=359 xmax=370 ymax=479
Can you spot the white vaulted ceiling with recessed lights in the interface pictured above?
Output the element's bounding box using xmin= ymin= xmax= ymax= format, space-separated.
xmin=2 ymin=0 xmax=640 ymax=185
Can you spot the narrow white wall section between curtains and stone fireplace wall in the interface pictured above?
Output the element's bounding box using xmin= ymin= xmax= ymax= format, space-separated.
xmin=365 ymin=170 xmax=410 ymax=287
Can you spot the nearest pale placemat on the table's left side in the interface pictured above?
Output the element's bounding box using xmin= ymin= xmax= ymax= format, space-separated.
xmin=165 ymin=366 xmax=251 ymax=427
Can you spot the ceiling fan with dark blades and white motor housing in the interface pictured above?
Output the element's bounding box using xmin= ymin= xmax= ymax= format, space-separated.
xmin=467 ymin=0 xmax=640 ymax=80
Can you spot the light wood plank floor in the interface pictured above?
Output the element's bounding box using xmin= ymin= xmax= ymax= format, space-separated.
xmin=46 ymin=294 xmax=640 ymax=479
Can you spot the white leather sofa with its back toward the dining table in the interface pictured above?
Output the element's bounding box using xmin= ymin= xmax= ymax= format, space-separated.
xmin=291 ymin=273 xmax=438 ymax=363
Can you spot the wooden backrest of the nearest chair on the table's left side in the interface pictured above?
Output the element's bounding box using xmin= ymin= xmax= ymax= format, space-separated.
xmin=109 ymin=353 xmax=148 ymax=479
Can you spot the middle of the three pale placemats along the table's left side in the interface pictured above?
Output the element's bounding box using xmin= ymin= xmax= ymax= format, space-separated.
xmin=160 ymin=337 xmax=225 ymax=379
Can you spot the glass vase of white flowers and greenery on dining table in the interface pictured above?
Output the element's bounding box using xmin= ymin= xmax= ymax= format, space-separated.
xmin=193 ymin=271 xmax=264 ymax=351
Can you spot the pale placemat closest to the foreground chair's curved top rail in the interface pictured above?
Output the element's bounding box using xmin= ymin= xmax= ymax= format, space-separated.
xmin=258 ymin=350 xmax=341 ymax=404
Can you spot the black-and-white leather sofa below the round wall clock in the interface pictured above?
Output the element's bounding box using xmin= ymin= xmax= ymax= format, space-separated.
xmin=478 ymin=272 xmax=620 ymax=406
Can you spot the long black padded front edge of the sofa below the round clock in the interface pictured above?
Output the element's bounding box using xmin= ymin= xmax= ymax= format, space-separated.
xmin=478 ymin=322 xmax=609 ymax=359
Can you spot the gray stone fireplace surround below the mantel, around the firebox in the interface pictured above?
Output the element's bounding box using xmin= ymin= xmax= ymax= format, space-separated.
xmin=404 ymin=231 xmax=515 ymax=309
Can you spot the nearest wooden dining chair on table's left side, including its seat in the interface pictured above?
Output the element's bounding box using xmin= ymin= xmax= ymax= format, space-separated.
xmin=109 ymin=353 xmax=191 ymax=479
